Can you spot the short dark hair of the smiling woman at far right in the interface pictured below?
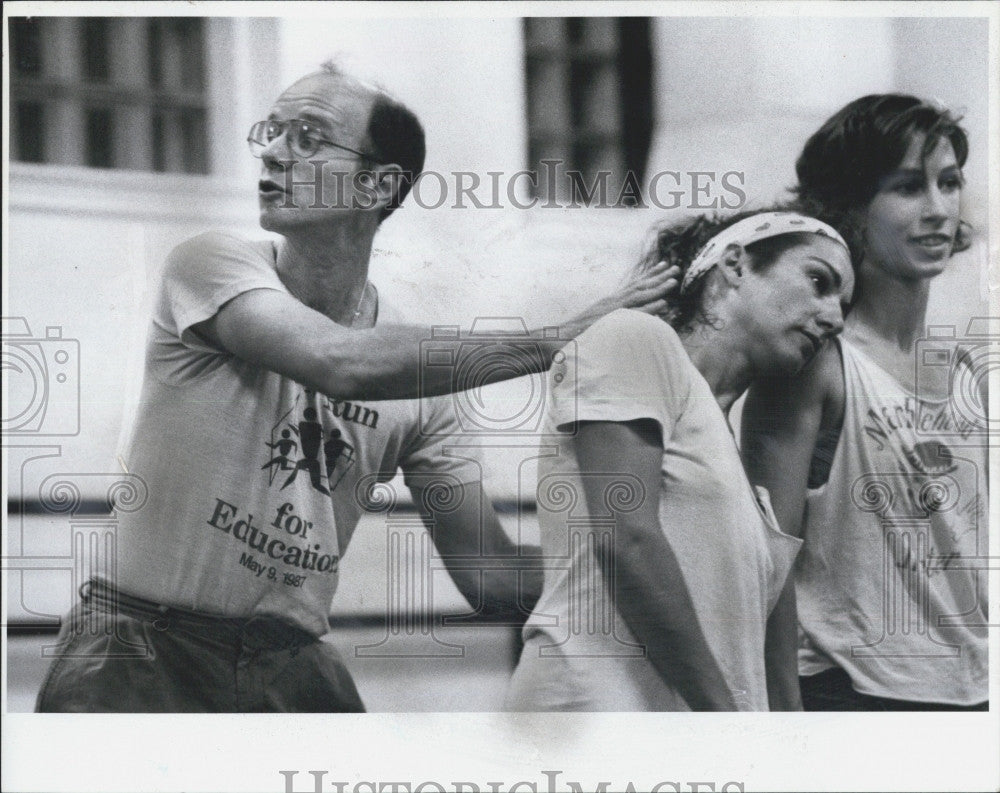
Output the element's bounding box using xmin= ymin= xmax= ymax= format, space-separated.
xmin=793 ymin=94 xmax=972 ymax=251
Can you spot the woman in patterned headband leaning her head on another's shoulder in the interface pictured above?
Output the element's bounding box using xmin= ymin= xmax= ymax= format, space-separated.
xmin=507 ymin=207 xmax=854 ymax=711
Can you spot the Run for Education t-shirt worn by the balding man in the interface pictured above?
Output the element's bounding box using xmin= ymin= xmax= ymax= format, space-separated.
xmin=116 ymin=232 xmax=479 ymax=635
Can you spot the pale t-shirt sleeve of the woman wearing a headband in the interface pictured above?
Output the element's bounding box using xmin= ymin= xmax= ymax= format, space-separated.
xmin=549 ymin=309 xmax=693 ymax=438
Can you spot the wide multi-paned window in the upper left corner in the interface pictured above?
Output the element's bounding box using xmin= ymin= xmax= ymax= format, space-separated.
xmin=9 ymin=17 xmax=209 ymax=173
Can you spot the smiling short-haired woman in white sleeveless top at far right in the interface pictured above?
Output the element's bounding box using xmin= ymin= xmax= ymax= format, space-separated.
xmin=742 ymin=94 xmax=988 ymax=710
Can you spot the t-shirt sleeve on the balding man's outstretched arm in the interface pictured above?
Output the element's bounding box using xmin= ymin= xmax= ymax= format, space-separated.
xmin=156 ymin=232 xmax=287 ymax=348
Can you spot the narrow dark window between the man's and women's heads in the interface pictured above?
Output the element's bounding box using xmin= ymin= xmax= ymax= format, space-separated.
xmin=524 ymin=17 xmax=653 ymax=205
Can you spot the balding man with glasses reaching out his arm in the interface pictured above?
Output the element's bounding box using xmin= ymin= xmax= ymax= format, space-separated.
xmin=37 ymin=67 xmax=671 ymax=712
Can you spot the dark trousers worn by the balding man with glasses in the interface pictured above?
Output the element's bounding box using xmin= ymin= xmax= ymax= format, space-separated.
xmin=35 ymin=582 xmax=364 ymax=713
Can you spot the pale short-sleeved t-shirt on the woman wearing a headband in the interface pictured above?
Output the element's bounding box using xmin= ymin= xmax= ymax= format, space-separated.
xmin=507 ymin=310 xmax=800 ymax=711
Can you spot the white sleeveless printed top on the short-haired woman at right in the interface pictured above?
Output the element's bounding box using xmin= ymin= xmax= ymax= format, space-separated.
xmin=795 ymin=339 xmax=989 ymax=705
